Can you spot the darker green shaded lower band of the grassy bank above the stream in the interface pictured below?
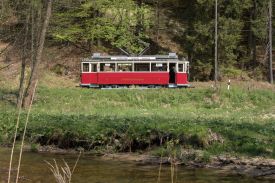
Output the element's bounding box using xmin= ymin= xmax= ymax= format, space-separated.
xmin=0 ymin=113 xmax=275 ymax=157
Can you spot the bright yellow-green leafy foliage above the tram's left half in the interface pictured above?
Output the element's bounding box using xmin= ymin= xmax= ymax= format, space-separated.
xmin=52 ymin=0 xmax=151 ymax=54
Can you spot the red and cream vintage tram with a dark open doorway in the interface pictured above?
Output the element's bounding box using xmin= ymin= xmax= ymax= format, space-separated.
xmin=81 ymin=53 xmax=189 ymax=88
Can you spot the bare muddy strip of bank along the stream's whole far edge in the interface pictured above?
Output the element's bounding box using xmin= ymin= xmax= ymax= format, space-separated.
xmin=0 ymin=145 xmax=275 ymax=181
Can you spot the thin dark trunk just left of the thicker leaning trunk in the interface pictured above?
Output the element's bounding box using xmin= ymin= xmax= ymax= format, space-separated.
xmin=17 ymin=15 xmax=29 ymax=107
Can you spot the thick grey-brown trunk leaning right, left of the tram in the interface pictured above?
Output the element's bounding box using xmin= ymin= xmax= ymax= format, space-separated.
xmin=23 ymin=0 xmax=52 ymax=107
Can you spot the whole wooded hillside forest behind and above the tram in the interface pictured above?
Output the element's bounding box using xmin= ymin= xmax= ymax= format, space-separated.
xmin=0 ymin=0 xmax=274 ymax=81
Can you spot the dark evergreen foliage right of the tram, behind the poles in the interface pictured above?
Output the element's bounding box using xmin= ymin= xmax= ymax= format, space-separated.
xmin=182 ymin=0 xmax=268 ymax=80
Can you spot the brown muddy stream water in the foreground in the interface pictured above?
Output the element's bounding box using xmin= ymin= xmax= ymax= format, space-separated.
xmin=0 ymin=148 xmax=272 ymax=183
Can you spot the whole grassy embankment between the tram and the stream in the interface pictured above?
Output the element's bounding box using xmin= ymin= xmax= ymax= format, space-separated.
xmin=0 ymin=76 xmax=275 ymax=161
